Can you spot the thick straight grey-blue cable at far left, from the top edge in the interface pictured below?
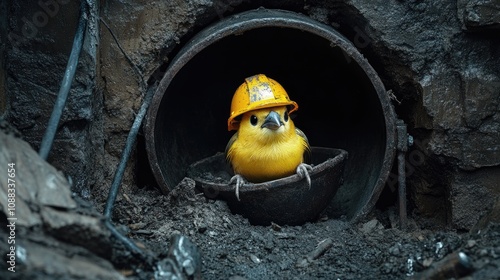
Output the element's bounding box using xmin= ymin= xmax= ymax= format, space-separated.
xmin=39 ymin=0 xmax=87 ymax=160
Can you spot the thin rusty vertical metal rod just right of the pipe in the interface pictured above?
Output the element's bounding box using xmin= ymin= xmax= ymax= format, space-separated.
xmin=396 ymin=119 xmax=413 ymax=230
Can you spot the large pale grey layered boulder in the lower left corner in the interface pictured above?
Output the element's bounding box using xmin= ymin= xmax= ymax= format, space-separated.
xmin=0 ymin=130 xmax=127 ymax=279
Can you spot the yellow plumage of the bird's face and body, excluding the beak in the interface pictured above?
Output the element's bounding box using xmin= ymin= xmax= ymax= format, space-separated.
xmin=226 ymin=106 xmax=309 ymax=183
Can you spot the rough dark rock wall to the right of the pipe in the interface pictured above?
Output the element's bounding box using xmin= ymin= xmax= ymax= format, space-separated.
xmin=342 ymin=1 xmax=500 ymax=229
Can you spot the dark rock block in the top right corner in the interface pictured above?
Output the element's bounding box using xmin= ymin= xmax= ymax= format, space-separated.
xmin=457 ymin=0 xmax=500 ymax=31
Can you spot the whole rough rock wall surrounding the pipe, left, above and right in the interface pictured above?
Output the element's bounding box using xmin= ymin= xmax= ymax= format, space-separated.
xmin=0 ymin=0 xmax=500 ymax=229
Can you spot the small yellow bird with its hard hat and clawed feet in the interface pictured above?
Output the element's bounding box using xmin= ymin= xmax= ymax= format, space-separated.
xmin=226 ymin=74 xmax=312 ymax=200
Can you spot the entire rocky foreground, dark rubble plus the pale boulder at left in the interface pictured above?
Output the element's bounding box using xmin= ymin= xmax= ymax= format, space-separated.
xmin=0 ymin=123 xmax=500 ymax=279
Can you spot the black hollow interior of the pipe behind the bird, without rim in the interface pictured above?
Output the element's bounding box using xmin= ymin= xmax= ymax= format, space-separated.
xmin=146 ymin=10 xmax=393 ymax=221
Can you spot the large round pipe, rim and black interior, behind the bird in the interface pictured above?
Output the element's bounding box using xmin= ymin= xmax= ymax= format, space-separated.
xmin=145 ymin=9 xmax=396 ymax=220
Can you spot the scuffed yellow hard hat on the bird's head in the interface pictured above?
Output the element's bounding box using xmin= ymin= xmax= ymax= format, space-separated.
xmin=227 ymin=74 xmax=299 ymax=131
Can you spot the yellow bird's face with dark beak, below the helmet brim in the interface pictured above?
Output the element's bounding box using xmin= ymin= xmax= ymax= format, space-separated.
xmin=238 ymin=106 xmax=295 ymax=142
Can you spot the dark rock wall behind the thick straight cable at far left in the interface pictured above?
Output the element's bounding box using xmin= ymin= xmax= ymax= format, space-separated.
xmin=2 ymin=0 xmax=102 ymax=200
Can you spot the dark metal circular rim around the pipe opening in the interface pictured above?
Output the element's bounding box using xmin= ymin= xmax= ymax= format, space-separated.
xmin=145 ymin=8 xmax=396 ymax=221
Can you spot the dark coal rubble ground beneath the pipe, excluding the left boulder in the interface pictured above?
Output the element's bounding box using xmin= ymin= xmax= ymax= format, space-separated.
xmin=103 ymin=178 xmax=500 ymax=279
